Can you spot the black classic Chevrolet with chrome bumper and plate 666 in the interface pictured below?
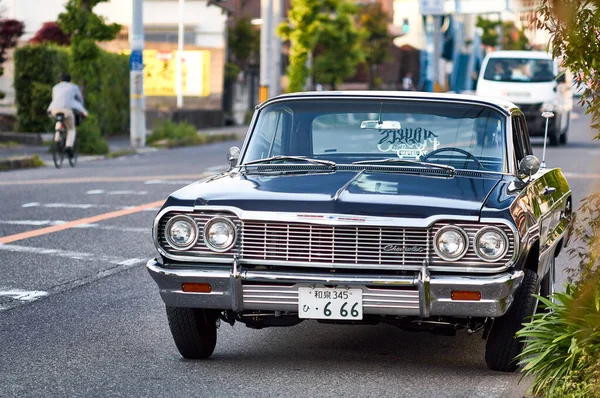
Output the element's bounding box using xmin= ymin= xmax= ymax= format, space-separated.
xmin=147 ymin=92 xmax=574 ymax=371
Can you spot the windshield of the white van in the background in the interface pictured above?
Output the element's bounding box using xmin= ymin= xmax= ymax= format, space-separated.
xmin=483 ymin=58 xmax=556 ymax=83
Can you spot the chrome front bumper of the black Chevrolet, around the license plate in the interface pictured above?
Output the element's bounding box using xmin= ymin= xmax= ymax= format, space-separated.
xmin=146 ymin=259 xmax=524 ymax=318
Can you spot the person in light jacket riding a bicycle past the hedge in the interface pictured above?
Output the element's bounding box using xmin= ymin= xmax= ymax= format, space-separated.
xmin=48 ymin=73 xmax=88 ymax=156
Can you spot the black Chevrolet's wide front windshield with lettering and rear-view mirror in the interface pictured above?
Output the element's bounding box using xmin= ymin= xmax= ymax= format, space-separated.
xmin=241 ymin=99 xmax=505 ymax=172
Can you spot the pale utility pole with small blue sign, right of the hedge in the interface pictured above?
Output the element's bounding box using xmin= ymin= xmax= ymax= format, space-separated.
xmin=129 ymin=0 xmax=146 ymax=148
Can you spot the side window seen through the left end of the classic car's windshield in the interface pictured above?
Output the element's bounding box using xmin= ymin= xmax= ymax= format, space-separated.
xmin=246 ymin=111 xmax=286 ymax=160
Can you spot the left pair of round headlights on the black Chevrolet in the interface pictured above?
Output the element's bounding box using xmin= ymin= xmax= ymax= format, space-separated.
xmin=165 ymin=215 xmax=235 ymax=252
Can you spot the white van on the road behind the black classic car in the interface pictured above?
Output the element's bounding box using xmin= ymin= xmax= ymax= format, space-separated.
xmin=476 ymin=51 xmax=573 ymax=146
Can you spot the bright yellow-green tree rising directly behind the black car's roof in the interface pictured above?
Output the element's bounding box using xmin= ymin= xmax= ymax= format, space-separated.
xmin=279 ymin=0 xmax=363 ymax=92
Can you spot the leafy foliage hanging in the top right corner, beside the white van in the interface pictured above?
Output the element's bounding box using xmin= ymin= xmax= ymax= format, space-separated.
xmin=537 ymin=0 xmax=600 ymax=134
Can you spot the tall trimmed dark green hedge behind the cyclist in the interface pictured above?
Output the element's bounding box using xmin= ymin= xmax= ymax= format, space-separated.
xmin=14 ymin=44 xmax=129 ymax=136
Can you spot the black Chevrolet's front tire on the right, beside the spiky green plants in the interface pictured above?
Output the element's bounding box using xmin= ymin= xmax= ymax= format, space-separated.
xmin=485 ymin=270 xmax=540 ymax=372
